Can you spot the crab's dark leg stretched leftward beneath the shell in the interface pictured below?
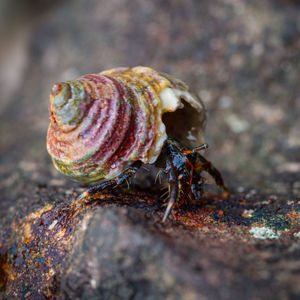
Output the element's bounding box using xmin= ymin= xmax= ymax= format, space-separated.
xmin=79 ymin=161 xmax=142 ymax=199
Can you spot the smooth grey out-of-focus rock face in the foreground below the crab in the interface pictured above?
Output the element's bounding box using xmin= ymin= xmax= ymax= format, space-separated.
xmin=62 ymin=207 xmax=299 ymax=299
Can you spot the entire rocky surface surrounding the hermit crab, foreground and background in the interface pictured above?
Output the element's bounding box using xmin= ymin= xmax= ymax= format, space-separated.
xmin=0 ymin=0 xmax=300 ymax=299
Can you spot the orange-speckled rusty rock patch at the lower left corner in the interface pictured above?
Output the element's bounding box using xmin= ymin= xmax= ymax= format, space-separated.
xmin=0 ymin=199 xmax=88 ymax=298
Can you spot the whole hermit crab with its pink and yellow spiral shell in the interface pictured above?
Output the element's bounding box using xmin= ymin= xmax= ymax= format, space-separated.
xmin=47 ymin=66 xmax=228 ymax=221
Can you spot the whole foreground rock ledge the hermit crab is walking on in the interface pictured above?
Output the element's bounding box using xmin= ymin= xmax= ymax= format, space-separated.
xmin=0 ymin=189 xmax=300 ymax=299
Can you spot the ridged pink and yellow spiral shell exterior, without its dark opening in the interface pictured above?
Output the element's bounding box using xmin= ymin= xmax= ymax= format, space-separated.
xmin=47 ymin=67 xmax=206 ymax=182
